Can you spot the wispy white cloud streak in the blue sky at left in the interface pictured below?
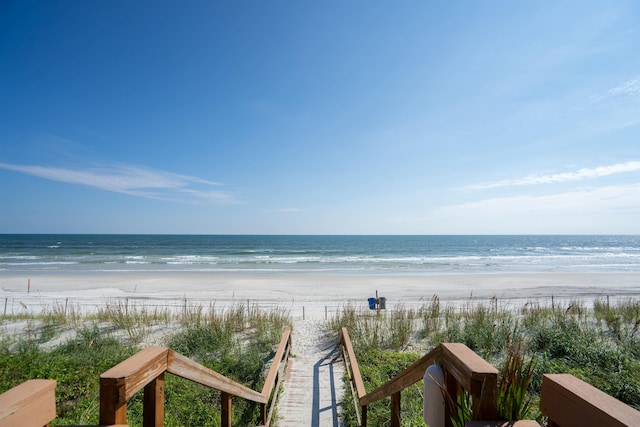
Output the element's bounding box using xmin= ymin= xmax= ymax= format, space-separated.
xmin=0 ymin=163 xmax=236 ymax=203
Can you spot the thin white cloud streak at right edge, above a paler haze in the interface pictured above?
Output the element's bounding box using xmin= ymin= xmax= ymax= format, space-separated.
xmin=466 ymin=161 xmax=640 ymax=190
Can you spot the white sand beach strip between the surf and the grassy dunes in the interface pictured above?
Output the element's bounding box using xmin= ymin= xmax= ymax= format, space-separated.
xmin=0 ymin=272 xmax=640 ymax=319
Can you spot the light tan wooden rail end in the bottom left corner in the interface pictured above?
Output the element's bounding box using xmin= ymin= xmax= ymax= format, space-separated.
xmin=0 ymin=380 xmax=56 ymax=427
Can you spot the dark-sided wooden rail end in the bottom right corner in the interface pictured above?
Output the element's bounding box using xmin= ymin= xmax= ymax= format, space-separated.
xmin=540 ymin=374 xmax=640 ymax=427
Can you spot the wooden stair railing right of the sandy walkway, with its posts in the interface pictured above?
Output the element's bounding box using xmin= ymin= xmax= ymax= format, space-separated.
xmin=340 ymin=328 xmax=498 ymax=427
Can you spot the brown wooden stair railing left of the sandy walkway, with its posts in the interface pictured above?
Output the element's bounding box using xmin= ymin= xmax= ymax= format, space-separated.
xmin=100 ymin=328 xmax=291 ymax=427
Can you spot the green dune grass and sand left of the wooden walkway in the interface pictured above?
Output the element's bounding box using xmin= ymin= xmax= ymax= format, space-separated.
xmin=0 ymin=303 xmax=290 ymax=426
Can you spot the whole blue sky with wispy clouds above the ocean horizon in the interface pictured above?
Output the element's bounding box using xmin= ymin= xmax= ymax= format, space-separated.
xmin=0 ymin=0 xmax=640 ymax=234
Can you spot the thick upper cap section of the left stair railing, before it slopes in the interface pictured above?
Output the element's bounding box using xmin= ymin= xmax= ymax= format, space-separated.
xmin=100 ymin=347 xmax=169 ymax=401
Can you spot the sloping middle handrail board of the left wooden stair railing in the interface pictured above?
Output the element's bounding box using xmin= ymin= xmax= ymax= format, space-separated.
xmin=167 ymin=350 xmax=267 ymax=403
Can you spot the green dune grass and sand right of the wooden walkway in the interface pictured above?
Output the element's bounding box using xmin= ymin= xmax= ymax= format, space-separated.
xmin=331 ymin=297 xmax=640 ymax=426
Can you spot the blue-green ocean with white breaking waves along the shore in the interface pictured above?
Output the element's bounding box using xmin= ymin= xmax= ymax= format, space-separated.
xmin=0 ymin=234 xmax=640 ymax=274
